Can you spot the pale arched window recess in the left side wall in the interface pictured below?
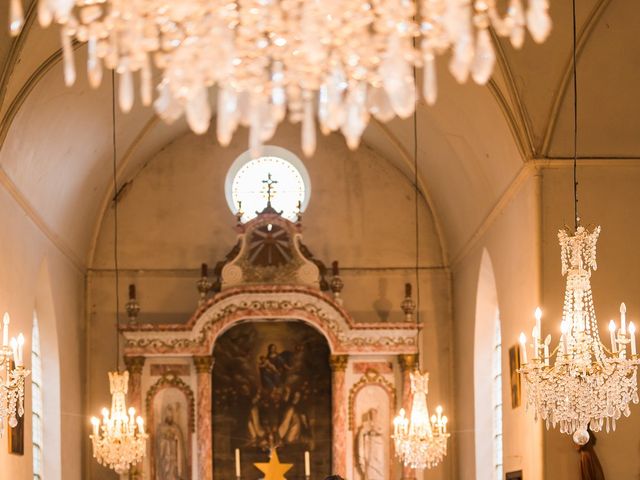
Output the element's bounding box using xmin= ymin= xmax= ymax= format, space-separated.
xmin=34 ymin=259 xmax=62 ymax=480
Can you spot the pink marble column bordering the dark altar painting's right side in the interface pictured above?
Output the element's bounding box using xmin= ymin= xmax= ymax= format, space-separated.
xmin=330 ymin=355 xmax=349 ymax=478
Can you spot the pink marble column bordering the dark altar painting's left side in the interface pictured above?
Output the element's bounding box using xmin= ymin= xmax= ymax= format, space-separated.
xmin=193 ymin=355 xmax=213 ymax=480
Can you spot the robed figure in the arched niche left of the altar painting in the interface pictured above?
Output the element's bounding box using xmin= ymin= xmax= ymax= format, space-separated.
xmin=155 ymin=404 xmax=187 ymax=480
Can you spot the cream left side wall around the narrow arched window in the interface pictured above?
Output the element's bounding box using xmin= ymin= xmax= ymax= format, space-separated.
xmin=0 ymin=174 xmax=88 ymax=480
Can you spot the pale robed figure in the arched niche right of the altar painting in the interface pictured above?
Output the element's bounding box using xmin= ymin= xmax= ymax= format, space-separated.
xmin=356 ymin=408 xmax=385 ymax=480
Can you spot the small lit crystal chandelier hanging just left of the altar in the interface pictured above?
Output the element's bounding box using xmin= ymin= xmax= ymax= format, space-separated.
xmin=89 ymin=371 xmax=147 ymax=474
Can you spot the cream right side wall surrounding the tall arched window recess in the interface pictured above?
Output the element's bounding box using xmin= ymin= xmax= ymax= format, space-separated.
xmin=452 ymin=175 xmax=543 ymax=480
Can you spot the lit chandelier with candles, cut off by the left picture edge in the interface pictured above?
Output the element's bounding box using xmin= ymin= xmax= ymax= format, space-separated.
xmin=0 ymin=312 xmax=31 ymax=437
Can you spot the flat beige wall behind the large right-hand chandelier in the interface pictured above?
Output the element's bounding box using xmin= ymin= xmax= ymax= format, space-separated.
xmin=542 ymin=161 xmax=640 ymax=480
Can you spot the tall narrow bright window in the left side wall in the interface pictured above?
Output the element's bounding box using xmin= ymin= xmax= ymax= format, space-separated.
xmin=31 ymin=312 xmax=42 ymax=480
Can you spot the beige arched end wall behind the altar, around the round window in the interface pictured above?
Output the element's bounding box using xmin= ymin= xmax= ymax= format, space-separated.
xmin=87 ymin=125 xmax=453 ymax=480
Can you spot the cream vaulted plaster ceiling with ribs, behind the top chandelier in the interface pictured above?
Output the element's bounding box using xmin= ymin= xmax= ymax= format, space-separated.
xmin=0 ymin=0 xmax=640 ymax=268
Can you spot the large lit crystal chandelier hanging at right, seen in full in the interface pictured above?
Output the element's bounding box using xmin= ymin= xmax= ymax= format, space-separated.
xmin=520 ymin=226 xmax=639 ymax=445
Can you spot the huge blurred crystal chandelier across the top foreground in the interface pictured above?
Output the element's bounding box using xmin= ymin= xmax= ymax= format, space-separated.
xmin=10 ymin=0 xmax=551 ymax=155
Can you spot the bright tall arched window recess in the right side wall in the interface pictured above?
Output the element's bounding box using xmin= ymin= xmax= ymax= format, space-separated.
xmin=473 ymin=249 xmax=502 ymax=480
